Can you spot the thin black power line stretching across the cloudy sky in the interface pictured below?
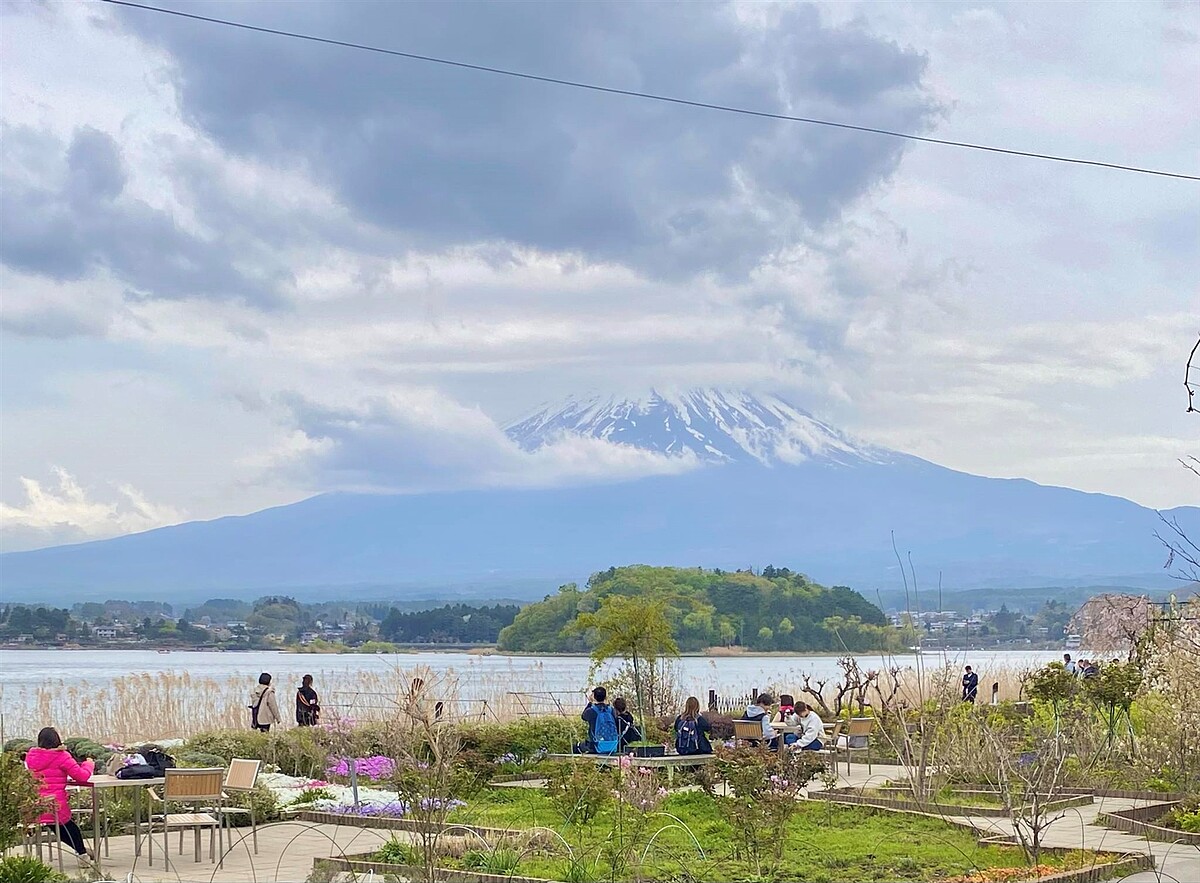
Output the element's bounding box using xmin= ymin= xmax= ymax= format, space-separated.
xmin=101 ymin=0 xmax=1200 ymax=181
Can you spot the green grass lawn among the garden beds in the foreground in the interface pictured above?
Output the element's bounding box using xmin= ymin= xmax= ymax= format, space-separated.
xmin=432 ymin=788 xmax=1089 ymax=883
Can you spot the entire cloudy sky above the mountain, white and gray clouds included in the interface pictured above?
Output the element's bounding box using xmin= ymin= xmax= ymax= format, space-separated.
xmin=0 ymin=0 xmax=1200 ymax=549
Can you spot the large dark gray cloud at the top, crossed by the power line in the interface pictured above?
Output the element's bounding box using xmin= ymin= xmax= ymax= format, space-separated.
xmin=119 ymin=2 xmax=937 ymax=275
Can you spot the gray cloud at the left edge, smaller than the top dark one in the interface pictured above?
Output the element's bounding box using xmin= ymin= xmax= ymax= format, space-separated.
xmin=0 ymin=126 xmax=289 ymax=316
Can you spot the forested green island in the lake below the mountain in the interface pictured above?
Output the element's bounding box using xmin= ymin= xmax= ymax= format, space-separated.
xmin=498 ymin=565 xmax=905 ymax=653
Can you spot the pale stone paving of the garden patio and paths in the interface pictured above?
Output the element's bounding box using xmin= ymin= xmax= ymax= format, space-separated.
xmin=21 ymin=764 xmax=1200 ymax=883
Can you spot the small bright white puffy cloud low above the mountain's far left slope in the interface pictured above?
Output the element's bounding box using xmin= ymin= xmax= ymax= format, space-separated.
xmin=0 ymin=467 xmax=185 ymax=551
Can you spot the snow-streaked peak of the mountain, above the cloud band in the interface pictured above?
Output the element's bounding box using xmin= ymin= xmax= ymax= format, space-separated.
xmin=506 ymin=389 xmax=889 ymax=464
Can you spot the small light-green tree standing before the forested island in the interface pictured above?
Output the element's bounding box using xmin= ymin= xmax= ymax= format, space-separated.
xmin=568 ymin=595 xmax=679 ymax=733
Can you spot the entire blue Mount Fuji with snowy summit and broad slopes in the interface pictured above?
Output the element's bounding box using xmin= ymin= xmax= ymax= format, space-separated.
xmin=0 ymin=390 xmax=1200 ymax=603
